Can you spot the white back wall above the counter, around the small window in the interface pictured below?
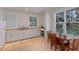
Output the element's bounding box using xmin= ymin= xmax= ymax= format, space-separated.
xmin=3 ymin=9 xmax=42 ymax=29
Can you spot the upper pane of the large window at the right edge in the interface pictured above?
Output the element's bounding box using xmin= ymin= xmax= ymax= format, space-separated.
xmin=66 ymin=8 xmax=79 ymax=22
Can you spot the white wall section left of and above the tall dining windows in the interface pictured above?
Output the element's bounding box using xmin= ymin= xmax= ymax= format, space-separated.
xmin=50 ymin=7 xmax=74 ymax=33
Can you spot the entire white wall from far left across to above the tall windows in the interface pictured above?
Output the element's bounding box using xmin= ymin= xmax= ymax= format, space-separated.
xmin=0 ymin=7 xmax=74 ymax=32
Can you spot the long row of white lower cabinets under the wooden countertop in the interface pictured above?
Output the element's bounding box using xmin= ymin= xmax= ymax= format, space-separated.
xmin=6 ymin=29 xmax=40 ymax=42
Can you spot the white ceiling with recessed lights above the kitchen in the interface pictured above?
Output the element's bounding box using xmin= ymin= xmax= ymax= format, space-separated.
xmin=2 ymin=7 xmax=55 ymax=13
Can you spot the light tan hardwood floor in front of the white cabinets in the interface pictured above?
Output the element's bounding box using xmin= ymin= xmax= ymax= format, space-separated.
xmin=2 ymin=37 xmax=51 ymax=51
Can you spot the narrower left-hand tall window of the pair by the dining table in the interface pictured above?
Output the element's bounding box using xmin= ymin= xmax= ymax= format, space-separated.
xmin=56 ymin=12 xmax=64 ymax=34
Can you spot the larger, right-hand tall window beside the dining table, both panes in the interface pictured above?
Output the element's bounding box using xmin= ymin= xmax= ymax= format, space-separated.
xmin=66 ymin=8 xmax=79 ymax=36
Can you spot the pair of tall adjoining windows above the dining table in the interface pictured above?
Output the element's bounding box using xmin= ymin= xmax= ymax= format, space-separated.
xmin=56 ymin=8 xmax=79 ymax=36
